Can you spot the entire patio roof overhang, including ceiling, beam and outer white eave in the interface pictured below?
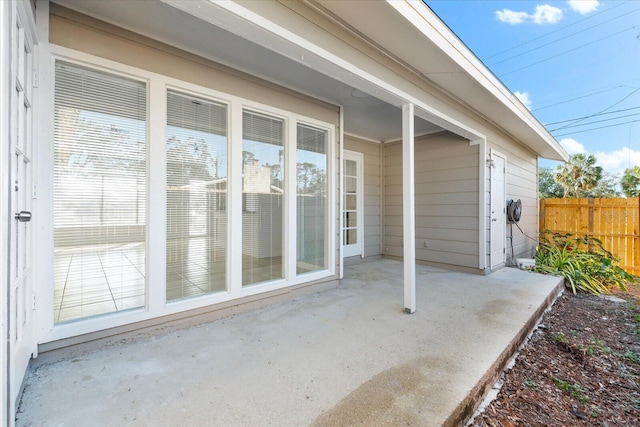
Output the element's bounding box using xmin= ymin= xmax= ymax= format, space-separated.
xmin=54 ymin=0 xmax=567 ymax=160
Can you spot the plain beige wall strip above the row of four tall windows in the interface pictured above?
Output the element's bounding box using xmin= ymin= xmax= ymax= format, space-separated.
xmin=49 ymin=4 xmax=339 ymax=125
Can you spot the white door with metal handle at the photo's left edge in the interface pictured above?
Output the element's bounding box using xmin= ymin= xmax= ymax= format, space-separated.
xmin=8 ymin=2 xmax=36 ymax=414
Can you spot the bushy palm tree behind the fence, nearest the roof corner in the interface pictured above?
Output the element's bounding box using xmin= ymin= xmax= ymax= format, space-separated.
xmin=556 ymin=154 xmax=602 ymax=197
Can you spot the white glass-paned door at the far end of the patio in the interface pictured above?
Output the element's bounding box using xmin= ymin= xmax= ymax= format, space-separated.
xmin=342 ymin=151 xmax=363 ymax=257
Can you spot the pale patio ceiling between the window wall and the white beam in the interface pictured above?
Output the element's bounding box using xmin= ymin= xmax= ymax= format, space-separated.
xmin=52 ymin=0 xmax=443 ymax=142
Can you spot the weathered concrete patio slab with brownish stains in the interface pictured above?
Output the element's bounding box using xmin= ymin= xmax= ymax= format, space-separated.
xmin=17 ymin=259 xmax=561 ymax=426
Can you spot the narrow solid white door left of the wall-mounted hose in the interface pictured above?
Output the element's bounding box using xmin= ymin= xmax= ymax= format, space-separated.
xmin=490 ymin=150 xmax=507 ymax=268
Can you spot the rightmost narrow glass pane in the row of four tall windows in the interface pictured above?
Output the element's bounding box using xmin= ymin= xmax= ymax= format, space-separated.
xmin=296 ymin=124 xmax=329 ymax=274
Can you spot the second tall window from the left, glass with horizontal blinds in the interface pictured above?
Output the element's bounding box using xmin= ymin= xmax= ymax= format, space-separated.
xmin=166 ymin=91 xmax=227 ymax=301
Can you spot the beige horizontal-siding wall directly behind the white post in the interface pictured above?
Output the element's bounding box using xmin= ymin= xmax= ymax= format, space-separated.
xmin=383 ymin=133 xmax=479 ymax=269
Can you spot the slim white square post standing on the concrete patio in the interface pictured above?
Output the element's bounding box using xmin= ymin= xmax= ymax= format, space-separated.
xmin=402 ymin=104 xmax=416 ymax=314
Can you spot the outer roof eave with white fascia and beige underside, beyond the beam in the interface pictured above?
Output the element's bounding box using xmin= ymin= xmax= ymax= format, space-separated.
xmin=309 ymin=0 xmax=568 ymax=161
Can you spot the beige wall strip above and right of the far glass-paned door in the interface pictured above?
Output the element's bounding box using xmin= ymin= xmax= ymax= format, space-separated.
xmin=344 ymin=135 xmax=382 ymax=257
